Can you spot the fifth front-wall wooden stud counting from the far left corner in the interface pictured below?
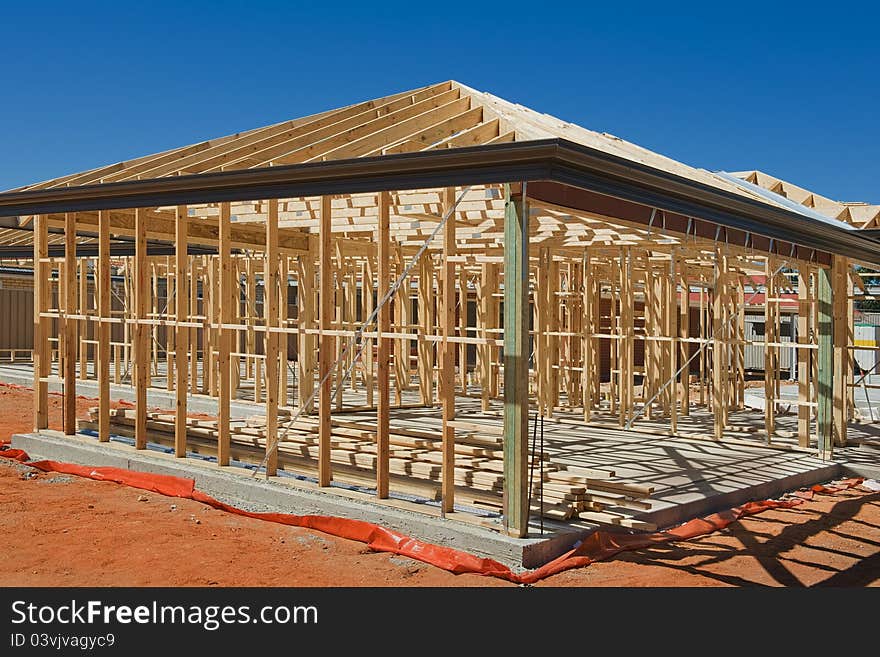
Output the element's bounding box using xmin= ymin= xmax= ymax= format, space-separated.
xmin=169 ymin=205 xmax=188 ymax=458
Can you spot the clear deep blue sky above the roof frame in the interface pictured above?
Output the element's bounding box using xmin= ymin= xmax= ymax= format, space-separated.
xmin=0 ymin=0 xmax=880 ymax=203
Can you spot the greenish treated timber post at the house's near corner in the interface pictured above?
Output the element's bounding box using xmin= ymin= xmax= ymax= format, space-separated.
xmin=504 ymin=185 xmax=529 ymax=537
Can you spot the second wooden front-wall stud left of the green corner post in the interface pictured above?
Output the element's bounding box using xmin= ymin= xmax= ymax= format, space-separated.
xmin=376 ymin=192 xmax=392 ymax=499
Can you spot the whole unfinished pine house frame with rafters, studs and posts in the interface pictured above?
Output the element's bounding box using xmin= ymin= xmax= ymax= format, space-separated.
xmin=0 ymin=82 xmax=880 ymax=536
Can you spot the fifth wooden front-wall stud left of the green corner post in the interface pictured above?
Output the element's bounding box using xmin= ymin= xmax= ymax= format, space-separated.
xmin=217 ymin=202 xmax=232 ymax=466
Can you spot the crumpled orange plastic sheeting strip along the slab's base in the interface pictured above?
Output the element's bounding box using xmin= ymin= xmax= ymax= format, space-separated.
xmin=0 ymin=450 xmax=862 ymax=584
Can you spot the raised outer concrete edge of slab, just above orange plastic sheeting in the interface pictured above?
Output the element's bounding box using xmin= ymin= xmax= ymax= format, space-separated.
xmin=12 ymin=431 xmax=880 ymax=569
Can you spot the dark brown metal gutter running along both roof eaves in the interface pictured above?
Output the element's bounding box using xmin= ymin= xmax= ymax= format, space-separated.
xmin=0 ymin=139 xmax=880 ymax=266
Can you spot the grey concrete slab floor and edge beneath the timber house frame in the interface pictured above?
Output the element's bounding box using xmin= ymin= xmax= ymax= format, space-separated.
xmin=0 ymin=363 xmax=880 ymax=568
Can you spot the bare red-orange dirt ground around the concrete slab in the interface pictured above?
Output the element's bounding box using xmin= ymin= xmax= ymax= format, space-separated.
xmin=0 ymin=386 xmax=880 ymax=586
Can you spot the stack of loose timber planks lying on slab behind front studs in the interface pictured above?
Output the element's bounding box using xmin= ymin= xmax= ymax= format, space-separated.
xmin=78 ymin=407 xmax=655 ymax=530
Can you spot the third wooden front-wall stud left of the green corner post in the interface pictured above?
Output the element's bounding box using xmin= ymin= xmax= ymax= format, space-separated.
xmin=318 ymin=196 xmax=336 ymax=486
